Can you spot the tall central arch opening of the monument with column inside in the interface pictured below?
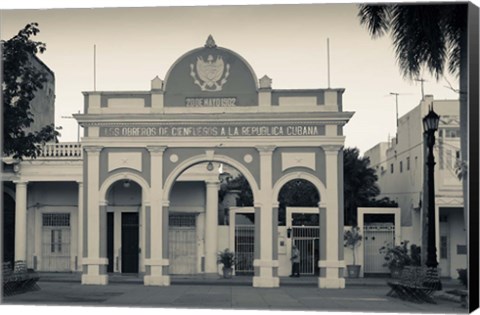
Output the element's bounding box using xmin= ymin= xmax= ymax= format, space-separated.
xmin=168 ymin=160 xmax=255 ymax=275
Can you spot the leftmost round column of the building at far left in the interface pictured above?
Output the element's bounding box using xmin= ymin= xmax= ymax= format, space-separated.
xmin=15 ymin=181 xmax=27 ymax=262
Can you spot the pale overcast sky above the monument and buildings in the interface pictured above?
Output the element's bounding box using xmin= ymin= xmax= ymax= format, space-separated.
xmin=0 ymin=1 xmax=464 ymax=153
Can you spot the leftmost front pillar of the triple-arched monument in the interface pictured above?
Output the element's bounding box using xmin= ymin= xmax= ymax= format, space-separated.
xmin=82 ymin=146 xmax=108 ymax=285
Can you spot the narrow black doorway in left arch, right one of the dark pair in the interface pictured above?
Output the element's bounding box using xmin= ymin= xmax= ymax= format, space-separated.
xmin=122 ymin=212 xmax=139 ymax=273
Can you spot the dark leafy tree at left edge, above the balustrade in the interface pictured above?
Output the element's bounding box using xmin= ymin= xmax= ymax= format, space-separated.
xmin=1 ymin=23 xmax=58 ymax=159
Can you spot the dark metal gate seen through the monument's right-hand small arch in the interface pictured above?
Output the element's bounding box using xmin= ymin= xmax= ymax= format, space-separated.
xmin=293 ymin=226 xmax=320 ymax=275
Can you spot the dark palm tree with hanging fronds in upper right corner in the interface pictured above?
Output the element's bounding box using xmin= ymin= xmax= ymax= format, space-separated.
xmin=358 ymin=3 xmax=468 ymax=236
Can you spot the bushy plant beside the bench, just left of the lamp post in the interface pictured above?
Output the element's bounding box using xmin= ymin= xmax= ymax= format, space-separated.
xmin=380 ymin=241 xmax=420 ymax=278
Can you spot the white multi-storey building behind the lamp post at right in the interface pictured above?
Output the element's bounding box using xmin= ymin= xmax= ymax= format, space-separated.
xmin=365 ymin=95 xmax=467 ymax=278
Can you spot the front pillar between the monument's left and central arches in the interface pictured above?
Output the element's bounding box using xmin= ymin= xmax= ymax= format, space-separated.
xmin=143 ymin=146 xmax=170 ymax=286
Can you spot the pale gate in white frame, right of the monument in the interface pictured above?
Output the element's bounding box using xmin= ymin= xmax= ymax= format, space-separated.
xmin=363 ymin=223 xmax=395 ymax=274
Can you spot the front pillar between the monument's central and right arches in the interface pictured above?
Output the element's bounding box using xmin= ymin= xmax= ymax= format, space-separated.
xmin=253 ymin=146 xmax=280 ymax=288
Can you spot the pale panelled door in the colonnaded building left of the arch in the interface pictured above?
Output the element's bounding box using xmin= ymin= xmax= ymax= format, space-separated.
xmin=42 ymin=213 xmax=70 ymax=271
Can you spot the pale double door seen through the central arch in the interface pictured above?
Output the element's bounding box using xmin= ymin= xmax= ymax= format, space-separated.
xmin=168 ymin=213 xmax=197 ymax=274
